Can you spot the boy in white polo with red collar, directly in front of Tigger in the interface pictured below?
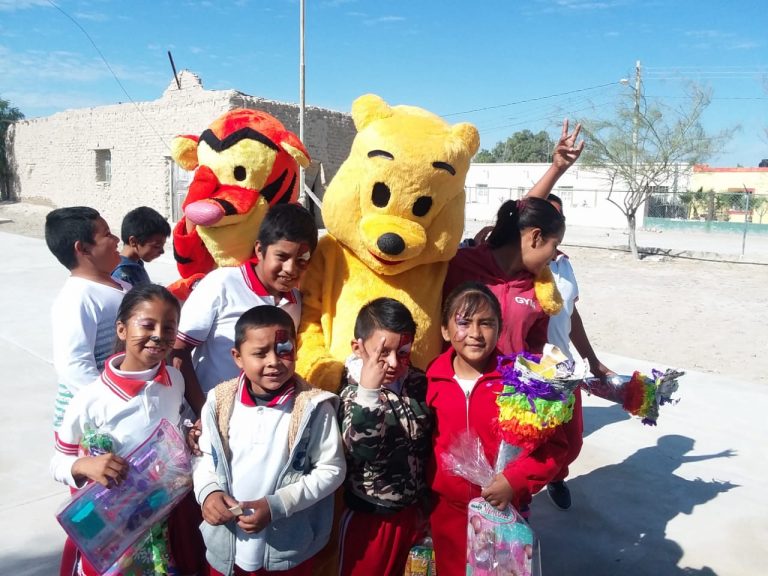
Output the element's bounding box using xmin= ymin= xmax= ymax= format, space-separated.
xmin=174 ymin=204 xmax=317 ymax=414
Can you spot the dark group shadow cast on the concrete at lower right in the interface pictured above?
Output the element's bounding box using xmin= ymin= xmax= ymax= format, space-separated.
xmin=531 ymin=434 xmax=736 ymax=576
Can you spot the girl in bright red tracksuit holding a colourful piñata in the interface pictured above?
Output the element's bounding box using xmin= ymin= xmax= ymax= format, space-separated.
xmin=427 ymin=282 xmax=567 ymax=576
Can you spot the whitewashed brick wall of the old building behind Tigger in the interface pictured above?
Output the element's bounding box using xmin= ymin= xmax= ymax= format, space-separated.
xmin=8 ymin=71 xmax=355 ymax=230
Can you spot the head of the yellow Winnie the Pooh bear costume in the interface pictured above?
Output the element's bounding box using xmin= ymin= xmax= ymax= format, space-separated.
xmin=323 ymin=94 xmax=480 ymax=276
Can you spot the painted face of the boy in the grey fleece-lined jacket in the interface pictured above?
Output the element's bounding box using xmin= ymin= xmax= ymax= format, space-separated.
xmin=232 ymin=326 xmax=296 ymax=394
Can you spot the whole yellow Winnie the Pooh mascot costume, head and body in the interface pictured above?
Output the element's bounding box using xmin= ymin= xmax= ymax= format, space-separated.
xmin=297 ymin=94 xmax=480 ymax=392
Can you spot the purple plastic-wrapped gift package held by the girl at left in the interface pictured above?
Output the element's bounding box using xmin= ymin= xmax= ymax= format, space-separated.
xmin=56 ymin=420 xmax=192 ymax=573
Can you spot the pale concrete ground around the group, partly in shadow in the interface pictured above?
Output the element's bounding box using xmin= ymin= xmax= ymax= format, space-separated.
xmin=0 ymin=232 xmax=768 ymax=576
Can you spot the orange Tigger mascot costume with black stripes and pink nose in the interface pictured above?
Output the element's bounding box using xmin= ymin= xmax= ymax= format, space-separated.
xmin=169 ymin=108 xmax=310 ymax=301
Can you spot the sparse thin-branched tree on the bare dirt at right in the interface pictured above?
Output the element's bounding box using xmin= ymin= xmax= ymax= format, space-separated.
xmin=581 ymin=85 xmax=735 ymax=258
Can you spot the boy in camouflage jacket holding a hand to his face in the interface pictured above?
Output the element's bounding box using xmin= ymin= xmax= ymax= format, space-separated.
xmin=339 ymin=298 xmax=432 ymax=576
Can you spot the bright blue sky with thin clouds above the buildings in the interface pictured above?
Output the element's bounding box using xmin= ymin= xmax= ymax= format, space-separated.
xmin=0 ymin=0 xmax=768 ymax=166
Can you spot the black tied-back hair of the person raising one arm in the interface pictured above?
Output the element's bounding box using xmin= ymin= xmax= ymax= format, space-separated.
xmin=488 ymin=198 xmax=565 ymax=248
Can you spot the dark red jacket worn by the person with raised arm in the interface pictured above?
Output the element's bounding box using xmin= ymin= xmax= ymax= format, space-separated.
xmin=443 ymin=244 xmax=549 ymax=354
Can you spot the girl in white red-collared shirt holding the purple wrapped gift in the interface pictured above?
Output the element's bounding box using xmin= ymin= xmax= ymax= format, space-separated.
xmin=51 ymin=284 xmax=207 ymax=576
